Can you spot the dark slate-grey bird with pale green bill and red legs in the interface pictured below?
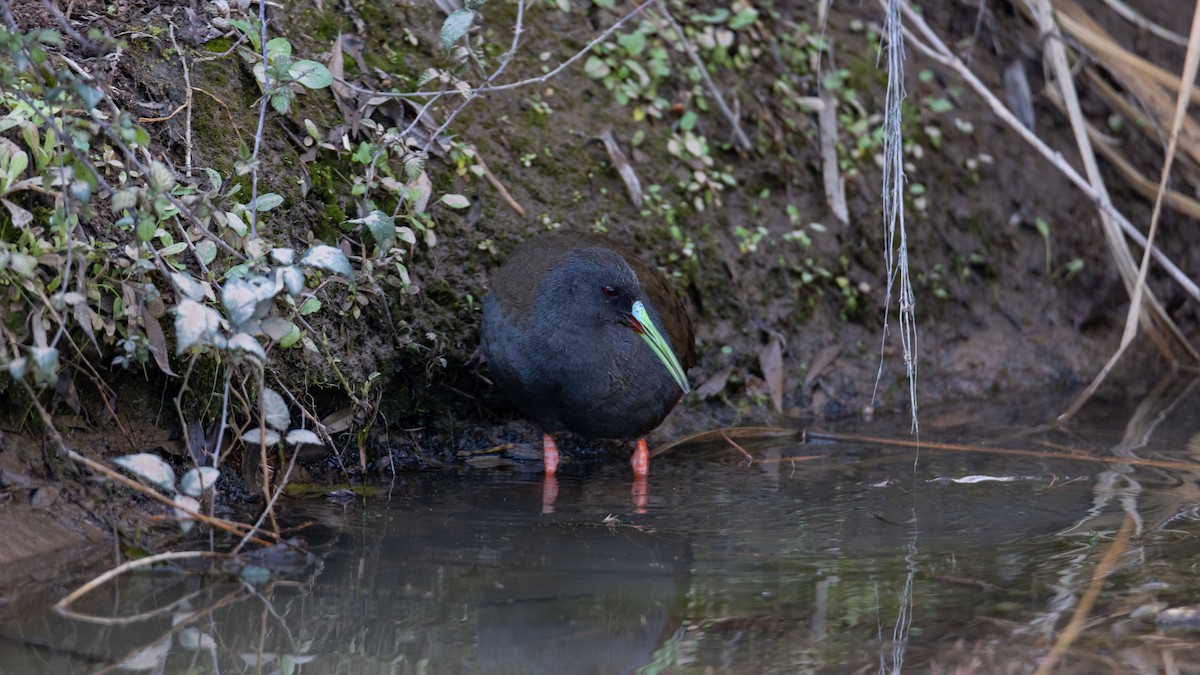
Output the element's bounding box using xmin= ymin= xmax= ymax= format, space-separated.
xmin=482 ymin=232 xmax=696 ymax=477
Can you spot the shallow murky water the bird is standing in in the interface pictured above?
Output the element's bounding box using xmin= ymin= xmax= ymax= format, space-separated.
xmin=0 ymin=386 xmax=1200 ymax=674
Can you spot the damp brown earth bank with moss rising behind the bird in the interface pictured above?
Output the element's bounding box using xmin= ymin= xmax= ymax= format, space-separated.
xmin=0 ymin=0 xmax=1200 ymax=581
